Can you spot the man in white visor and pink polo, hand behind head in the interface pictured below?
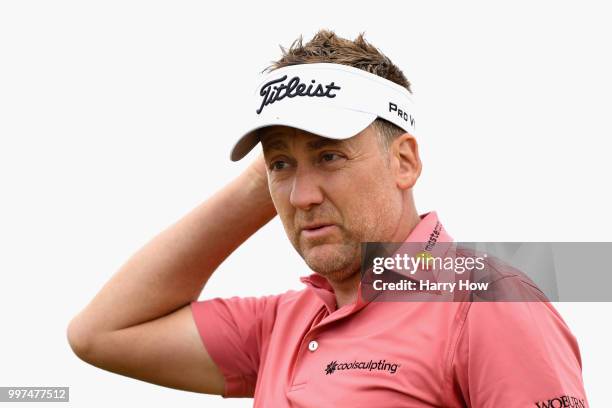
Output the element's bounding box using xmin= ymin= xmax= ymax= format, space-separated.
xmin=68 ymin=30 xmax=587 ymax=407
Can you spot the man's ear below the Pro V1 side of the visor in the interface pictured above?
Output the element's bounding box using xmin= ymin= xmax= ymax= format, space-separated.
xmin=390 ymin=133 xmax=421 ymax=190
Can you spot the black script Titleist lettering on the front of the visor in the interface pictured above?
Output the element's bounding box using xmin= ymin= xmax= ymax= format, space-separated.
xmin=256 ymin=75 xmax=340 ymax=115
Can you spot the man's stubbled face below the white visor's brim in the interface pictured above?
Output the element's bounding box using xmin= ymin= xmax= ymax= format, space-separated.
xmin=261 ymin=126 xmax=402 ymax=281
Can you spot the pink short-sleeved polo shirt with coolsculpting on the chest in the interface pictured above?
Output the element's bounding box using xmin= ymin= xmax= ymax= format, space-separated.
xmin=191 ymin=212 xmax=588 ymax=408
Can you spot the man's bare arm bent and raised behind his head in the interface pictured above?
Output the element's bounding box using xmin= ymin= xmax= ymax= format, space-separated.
xmin=67 ymin=155 xmax=276 ymax=394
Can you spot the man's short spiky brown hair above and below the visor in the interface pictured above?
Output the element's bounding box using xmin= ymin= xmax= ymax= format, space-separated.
xmin=264 ymin=29 xmax=412 ymax=149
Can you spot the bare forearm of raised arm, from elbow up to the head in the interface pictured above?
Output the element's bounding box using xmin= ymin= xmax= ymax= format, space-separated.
xmin=71 ymin=158 xmax=276 ymax=335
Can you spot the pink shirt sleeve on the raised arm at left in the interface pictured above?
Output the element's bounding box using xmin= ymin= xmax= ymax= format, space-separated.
xmin=191 ymin=295 xmax=282 ymax=398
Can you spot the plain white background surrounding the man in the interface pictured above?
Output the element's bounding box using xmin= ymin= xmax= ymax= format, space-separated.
xmin=0 ymin=0 xmax=612 ymax=407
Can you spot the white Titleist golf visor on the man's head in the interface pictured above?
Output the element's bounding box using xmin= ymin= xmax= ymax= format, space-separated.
xmin=230 ymin=63 xmax=414 ymax=161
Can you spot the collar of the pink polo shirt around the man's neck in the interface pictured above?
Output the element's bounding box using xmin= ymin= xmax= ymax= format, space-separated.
xmin=300 ymin=211 xmax=453 ymax=316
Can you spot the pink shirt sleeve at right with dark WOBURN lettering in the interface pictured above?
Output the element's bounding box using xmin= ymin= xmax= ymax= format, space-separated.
xmin=452 ymin=290 xmax=588 ymax=408
